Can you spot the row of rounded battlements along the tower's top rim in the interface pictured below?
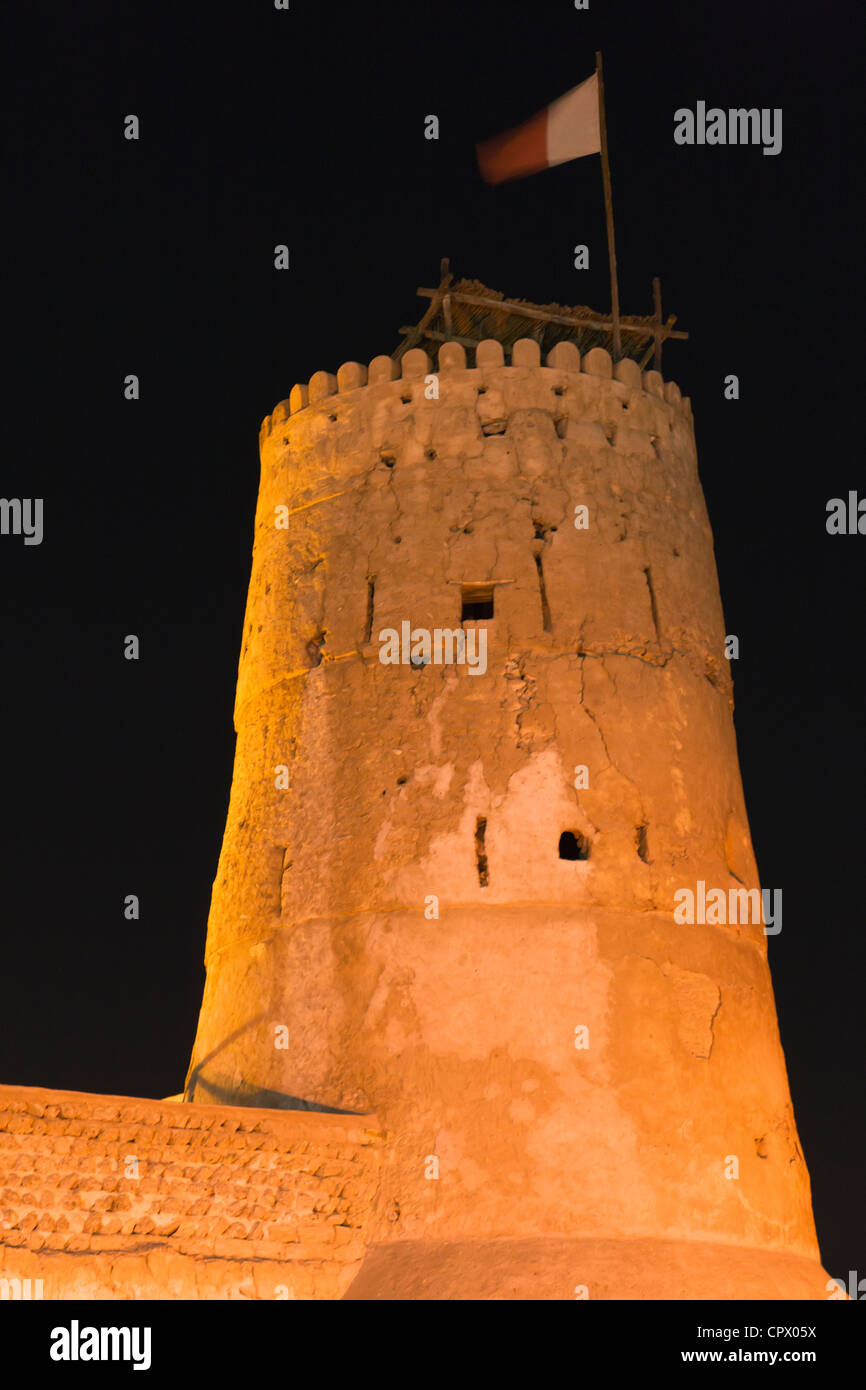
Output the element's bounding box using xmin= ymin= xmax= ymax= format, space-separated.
xmin=259 ymin=338 xmax=692 ymax=442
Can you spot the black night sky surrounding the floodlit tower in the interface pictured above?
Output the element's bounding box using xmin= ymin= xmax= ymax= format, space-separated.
xmin=0 ymin=0 xmax=866 ymax=1275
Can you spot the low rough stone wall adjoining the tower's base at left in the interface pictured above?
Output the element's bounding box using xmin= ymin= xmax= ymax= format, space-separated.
xmin=0 ymin=1086 xmax=382 ymax=1298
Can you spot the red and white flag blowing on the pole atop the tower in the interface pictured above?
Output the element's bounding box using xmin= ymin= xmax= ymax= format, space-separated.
xmin=475 ymin=72 xmax=602 ymax=183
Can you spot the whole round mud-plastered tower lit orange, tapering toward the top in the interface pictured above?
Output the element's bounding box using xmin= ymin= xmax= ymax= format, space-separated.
xmin=185 ymin=290 xmax=827 ymax=1298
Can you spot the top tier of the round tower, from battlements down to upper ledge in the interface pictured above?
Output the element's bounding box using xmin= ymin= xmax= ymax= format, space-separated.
xmin=236 ymin=338 xmax=711 ymax=739
